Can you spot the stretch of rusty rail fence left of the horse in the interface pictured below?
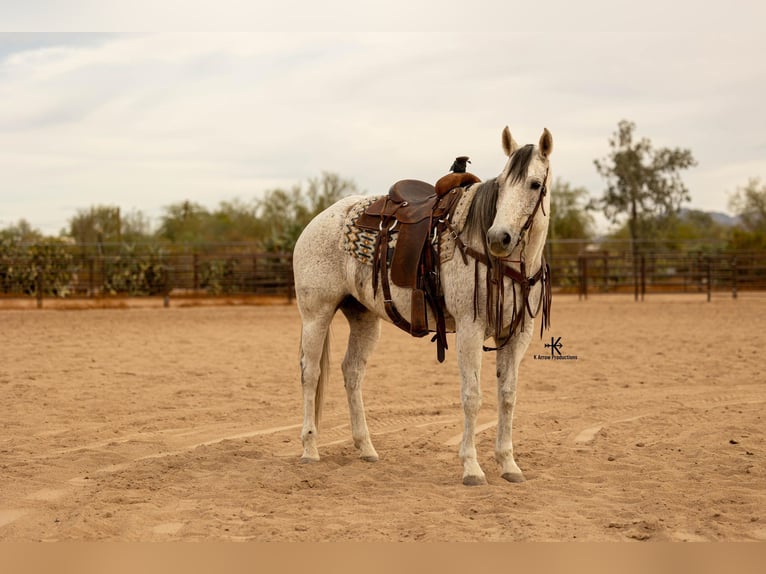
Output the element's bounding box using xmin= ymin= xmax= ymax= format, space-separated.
xmin=0 ymin=245 xmax=294 ymax=306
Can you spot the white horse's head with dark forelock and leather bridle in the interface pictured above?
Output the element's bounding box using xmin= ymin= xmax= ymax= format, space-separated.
xmin=486 ymin=127 xmax=553 ymax=259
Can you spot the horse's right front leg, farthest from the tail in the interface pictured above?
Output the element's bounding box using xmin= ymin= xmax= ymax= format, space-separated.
xmin=495 ymin=321 xmax=532 ymax=482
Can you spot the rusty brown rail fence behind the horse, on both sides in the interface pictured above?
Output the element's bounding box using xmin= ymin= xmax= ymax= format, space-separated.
xmin=0 ymin=241 xmax=766 ymax=306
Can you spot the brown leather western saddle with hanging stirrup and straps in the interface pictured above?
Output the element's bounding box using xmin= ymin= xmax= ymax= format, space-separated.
xmin=356 ymin=172 xmax=480 ymax=362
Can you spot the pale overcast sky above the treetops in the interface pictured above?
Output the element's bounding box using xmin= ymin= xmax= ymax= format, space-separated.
xmin=0 ymin=0 xmax=766 ymax=234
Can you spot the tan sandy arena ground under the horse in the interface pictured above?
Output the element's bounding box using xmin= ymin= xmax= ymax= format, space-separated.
xmin=0 ymin=294 xmax=766 ymax=541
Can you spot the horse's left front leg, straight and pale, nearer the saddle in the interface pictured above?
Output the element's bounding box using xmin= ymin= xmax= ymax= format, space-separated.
xmin=457 ymin=323 xmax=487 ymax=486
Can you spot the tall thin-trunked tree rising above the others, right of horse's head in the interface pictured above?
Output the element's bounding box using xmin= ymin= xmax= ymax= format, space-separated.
xmin=592 ymin=120 xmax=696 ymax=300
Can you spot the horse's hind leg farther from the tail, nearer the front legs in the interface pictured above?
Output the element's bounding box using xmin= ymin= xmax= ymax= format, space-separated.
xmin=341 ymin=297 xmax=380 ymax=462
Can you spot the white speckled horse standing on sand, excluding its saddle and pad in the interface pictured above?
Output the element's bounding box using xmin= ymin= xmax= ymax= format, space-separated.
xmin=293 ymin=126 xmax=553 ymax=486
